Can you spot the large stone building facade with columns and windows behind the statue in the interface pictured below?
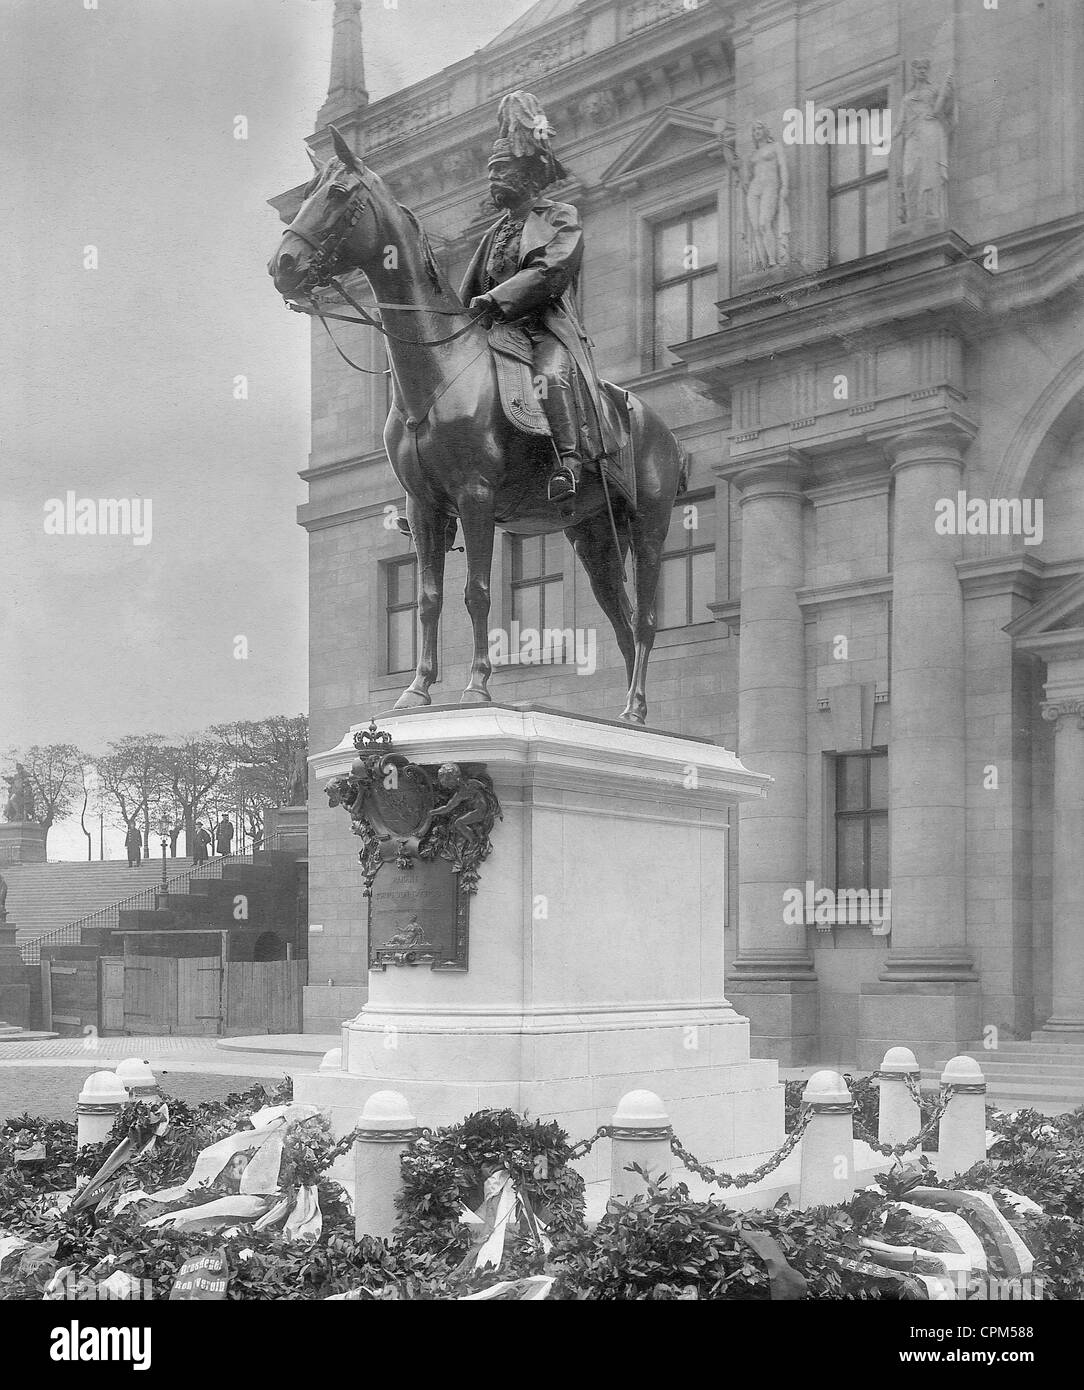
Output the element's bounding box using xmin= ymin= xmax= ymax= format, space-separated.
xmin=283 ymin=0 xmax=1084 ymax=1066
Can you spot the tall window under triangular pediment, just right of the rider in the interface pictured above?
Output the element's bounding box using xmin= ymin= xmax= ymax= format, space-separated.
xmin=652 ymin=206 xmax=718 ymax=367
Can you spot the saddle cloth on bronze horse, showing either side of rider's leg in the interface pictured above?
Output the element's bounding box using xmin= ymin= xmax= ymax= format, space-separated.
xmin=489 ymin=324 xmax=637 ymax=509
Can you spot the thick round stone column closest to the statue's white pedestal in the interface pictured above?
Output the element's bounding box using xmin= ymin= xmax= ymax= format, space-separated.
xmin=728 ymin=449 xmax=817 ymax=1066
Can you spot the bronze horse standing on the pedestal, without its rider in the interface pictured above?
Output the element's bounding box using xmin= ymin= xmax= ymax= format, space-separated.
xmin=275 ymin=128 xmax=687 ymax=724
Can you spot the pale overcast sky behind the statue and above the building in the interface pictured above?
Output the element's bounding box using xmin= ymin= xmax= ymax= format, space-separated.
xmin=0 ymin=0 xmax=529 ymax=858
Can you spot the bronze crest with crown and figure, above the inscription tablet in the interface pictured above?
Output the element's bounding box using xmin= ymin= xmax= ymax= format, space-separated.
xmin=324 ymin=721 xmax=502 ymax=898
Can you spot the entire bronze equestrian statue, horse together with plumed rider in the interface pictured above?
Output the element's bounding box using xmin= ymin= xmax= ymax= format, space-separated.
xmin=268 ymin=92 xmax=687 ymax=724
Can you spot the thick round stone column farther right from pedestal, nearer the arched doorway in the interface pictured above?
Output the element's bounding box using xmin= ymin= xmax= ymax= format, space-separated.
xmin=859 ymin=424 xmax=980 ymax=1068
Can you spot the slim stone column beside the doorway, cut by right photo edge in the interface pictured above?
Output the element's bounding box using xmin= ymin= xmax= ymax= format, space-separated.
xmin=1040 ymin=699 xmax=1084 ymax=1037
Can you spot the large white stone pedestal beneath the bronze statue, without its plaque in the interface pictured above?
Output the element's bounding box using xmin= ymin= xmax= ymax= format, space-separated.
xmin=295 ymin=705 xmax=784 ymax=1177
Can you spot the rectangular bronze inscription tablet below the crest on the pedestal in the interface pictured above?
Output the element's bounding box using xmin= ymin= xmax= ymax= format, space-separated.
xmin=368 ymin=859 xmax=470 ymax=970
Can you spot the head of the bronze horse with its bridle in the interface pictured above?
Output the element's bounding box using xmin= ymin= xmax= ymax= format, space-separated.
xmin=267 ymin=125 xmax=378 ymax=299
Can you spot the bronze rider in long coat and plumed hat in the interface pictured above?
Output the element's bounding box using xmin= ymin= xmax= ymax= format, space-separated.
xmin=460 ymin=92 xmax=616 ymax=502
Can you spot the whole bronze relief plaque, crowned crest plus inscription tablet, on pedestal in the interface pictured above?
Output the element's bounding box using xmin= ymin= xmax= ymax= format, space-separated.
xmin=325 ymin=723 xmax=500 ymax=970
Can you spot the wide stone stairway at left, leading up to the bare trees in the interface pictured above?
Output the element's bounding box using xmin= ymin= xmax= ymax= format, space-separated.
xmin=3 ymin=858 xmax=192 ymax=945
